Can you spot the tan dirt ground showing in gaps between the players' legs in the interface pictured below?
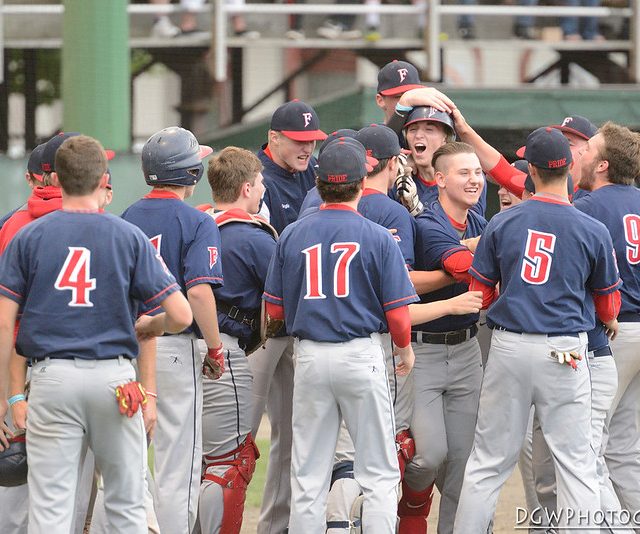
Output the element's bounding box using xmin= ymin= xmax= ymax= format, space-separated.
xmin=241 ymin=418 xmax=525 ymax=534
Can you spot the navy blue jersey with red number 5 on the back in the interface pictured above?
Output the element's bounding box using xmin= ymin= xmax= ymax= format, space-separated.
xmin=469 ymin=195 xmax=620 ymax=334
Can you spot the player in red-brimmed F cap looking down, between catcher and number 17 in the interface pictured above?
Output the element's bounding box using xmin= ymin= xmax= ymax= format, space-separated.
xmin=249 ymin=100 xmax=327 ymax=534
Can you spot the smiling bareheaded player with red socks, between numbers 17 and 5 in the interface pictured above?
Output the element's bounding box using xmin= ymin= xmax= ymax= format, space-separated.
xmin=398 ymin=141 xmax=486 ymax=534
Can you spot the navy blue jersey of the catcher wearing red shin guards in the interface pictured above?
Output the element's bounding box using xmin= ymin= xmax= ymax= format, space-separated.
xmin=213 ymin=210 xmax=276 ymax=343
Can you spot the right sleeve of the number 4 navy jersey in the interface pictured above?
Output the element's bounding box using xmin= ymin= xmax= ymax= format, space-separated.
xmin=131 ymin=231 xmax=180 ymax=311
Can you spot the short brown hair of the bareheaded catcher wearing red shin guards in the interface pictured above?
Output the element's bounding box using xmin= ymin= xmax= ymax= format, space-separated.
xmin=207 ymin=146 xmax=263 ymax=202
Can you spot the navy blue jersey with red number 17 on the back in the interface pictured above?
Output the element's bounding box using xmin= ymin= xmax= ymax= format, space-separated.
xmin=264 ymin=205 xmax=418 ymax=343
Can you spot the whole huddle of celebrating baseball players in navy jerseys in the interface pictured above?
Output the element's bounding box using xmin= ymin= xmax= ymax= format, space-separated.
xmin=0 ymin=61 xmax=640 ymax=534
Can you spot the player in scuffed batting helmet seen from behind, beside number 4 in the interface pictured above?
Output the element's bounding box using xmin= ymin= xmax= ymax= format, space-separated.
xmin=122 ymin=127 xmax=224 ymax=533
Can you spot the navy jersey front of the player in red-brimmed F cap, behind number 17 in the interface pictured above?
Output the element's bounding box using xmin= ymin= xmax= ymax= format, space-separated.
xmin=258 ymin=145 xmax=318 ymax=234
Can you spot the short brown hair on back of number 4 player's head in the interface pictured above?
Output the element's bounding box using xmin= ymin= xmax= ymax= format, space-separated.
xmin=55 ymin=135 xmax=107 ymax=196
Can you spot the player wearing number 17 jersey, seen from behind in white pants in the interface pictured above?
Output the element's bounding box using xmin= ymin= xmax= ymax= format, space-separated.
xmin=264 ymin=139 xmax=417 ymax=534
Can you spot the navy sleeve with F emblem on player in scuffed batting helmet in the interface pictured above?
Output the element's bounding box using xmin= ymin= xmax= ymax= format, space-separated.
xmin=184 ymin=215 xmax=223 ymax=289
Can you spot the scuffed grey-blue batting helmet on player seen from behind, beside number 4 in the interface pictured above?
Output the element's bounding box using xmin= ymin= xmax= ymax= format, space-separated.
xmin=142 ymin=126 xmax=213 ymax=186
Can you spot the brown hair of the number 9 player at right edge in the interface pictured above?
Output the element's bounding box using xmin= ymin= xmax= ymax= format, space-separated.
xmin=598 ymin=122 xmax=640 ymax=185
